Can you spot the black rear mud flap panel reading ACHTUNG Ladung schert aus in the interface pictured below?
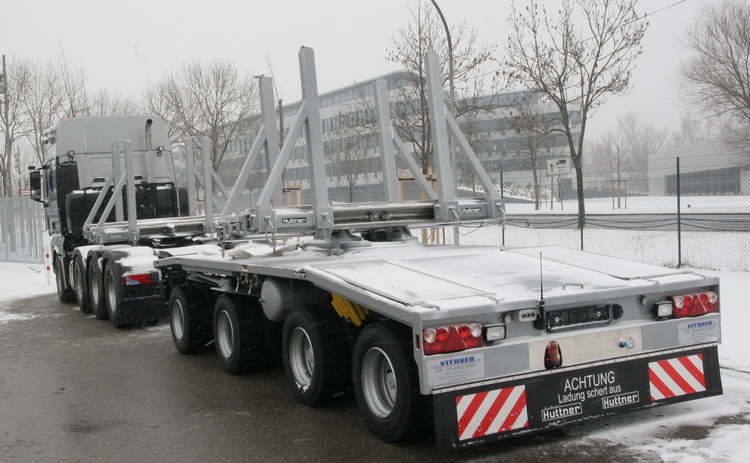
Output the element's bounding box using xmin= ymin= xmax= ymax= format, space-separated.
xmin=433 ymin=345 xmax=722 ymax=449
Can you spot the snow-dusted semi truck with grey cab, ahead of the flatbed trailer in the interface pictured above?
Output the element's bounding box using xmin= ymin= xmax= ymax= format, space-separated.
xmin=29 ymin=116 xmax=204 ymax=327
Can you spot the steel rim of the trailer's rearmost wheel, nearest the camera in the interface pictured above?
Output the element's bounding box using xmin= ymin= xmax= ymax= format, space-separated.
xmin=362 ymin=347 xmax=398 ymax=418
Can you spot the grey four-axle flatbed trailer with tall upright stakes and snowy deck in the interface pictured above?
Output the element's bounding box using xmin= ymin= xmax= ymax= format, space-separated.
xmin=154 ymin=48 xmax=722 ymax=448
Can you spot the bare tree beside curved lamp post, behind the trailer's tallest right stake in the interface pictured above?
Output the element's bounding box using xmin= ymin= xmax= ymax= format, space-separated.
xmin=387 ymin=1 xmax=493 ymax=173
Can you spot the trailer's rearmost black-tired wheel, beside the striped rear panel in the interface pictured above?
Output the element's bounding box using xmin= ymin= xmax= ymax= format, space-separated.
xmin=353 ymin=322 xmax=432 ymax=442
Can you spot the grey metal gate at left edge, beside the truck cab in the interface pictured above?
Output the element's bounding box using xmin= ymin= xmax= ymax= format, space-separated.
xmin=0 ymin=198 xmax=44 ymax=263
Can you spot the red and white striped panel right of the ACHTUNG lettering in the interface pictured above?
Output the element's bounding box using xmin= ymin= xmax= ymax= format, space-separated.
xmin=648 ymin=354 xmax=706 ymax=401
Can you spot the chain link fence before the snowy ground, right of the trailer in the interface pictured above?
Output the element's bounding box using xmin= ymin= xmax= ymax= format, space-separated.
xmin=446 ymin=160 xmax=750 ymax=271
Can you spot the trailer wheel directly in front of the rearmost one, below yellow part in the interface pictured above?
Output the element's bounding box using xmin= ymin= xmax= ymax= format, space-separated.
xmin=281 ymin=307 xmax=351 ymax=407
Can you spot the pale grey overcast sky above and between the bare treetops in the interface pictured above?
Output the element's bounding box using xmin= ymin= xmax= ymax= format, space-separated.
xmin=0 ymin=0 xmax=715 ymax=137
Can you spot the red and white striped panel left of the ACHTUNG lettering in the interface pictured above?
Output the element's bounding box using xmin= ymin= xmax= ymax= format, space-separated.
xmin=456 ymin=386 xmax=529 ymax=440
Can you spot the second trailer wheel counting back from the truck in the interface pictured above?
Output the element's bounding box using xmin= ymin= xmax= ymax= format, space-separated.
xmin=214 ymin=294 xmax=265 ymax=375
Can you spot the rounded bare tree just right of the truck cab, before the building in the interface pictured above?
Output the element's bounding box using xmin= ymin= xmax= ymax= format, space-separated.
xmin=145 ymin=61 xmax=258 ymax=170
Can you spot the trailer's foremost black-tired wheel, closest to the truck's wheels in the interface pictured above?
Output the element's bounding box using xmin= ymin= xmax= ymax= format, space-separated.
xmin=169 ymin=285 xmax=213 ymax=354
